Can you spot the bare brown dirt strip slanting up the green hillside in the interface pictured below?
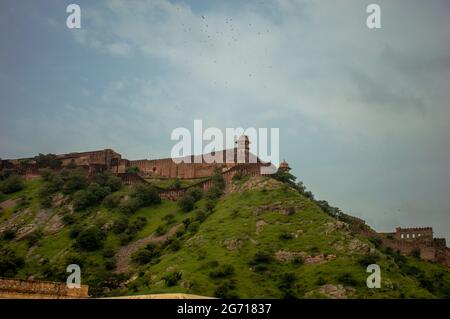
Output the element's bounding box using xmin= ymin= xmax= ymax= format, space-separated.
xmin=115 ymin=224 xmax=182 ymax=273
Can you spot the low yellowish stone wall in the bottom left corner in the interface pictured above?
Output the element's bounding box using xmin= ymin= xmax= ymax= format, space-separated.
xmin=0 ymin=278 xmax=89 ymax=299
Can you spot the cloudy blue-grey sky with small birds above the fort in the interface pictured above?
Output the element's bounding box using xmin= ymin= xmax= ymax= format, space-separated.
xmin=0 ymin=0 xmax=450 ymax=241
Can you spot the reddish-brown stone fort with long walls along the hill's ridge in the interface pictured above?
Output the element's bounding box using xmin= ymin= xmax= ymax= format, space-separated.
xmin=0 ymin=135 xmax=450 ymax=266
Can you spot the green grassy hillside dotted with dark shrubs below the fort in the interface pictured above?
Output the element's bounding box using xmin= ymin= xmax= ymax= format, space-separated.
xmin=0 ymin=172 xmax=450 ymax=298
